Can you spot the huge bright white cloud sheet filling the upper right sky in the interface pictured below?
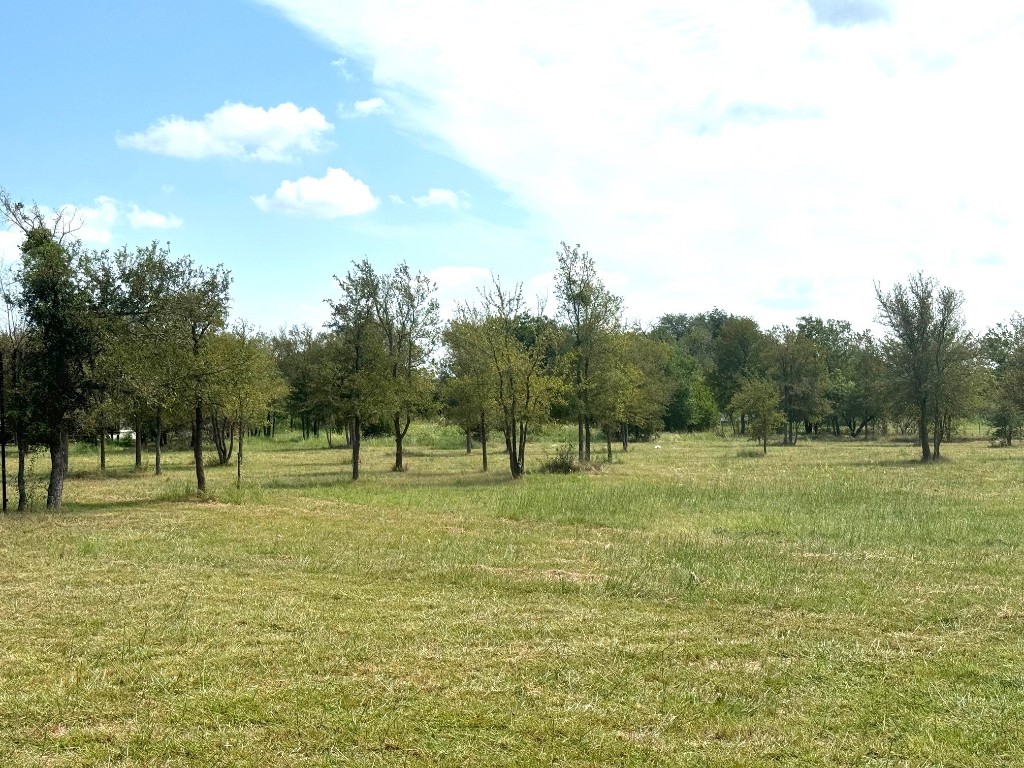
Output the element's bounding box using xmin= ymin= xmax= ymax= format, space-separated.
xmin=258 ymin=0 xmax=1024 ymax=326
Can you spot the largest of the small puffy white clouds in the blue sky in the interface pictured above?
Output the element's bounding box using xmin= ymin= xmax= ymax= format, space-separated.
xmin=117 ymin=102 xmax=334 ymax=162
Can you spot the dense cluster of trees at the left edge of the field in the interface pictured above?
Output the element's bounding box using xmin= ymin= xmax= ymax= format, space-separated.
xmin=0 ymin=190 xmax=287 ymax=510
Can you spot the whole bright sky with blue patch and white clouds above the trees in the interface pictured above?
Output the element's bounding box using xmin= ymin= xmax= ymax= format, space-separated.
xmin=0 ymin=0 xmax=1024 ymax=332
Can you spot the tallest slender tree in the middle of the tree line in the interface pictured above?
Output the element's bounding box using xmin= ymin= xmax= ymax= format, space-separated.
xmin=555 ymin=242 xmax=623 ymax=464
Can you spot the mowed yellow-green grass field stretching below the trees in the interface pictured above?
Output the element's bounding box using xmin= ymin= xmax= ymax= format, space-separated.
xmin=0 ymin=427 xmax=1024 ymax=768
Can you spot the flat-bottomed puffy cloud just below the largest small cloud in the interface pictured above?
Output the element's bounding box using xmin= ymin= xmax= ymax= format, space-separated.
xmin=253 ymin=168 xmax=377 ymax=219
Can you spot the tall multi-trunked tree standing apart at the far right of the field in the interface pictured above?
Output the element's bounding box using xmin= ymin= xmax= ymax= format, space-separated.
xmin=874 ymin=272 xmax=973 ymax=462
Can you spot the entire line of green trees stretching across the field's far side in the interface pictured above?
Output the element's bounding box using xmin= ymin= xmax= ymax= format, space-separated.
xmin=0 ymin=189 xmax=1024 ymax=509
